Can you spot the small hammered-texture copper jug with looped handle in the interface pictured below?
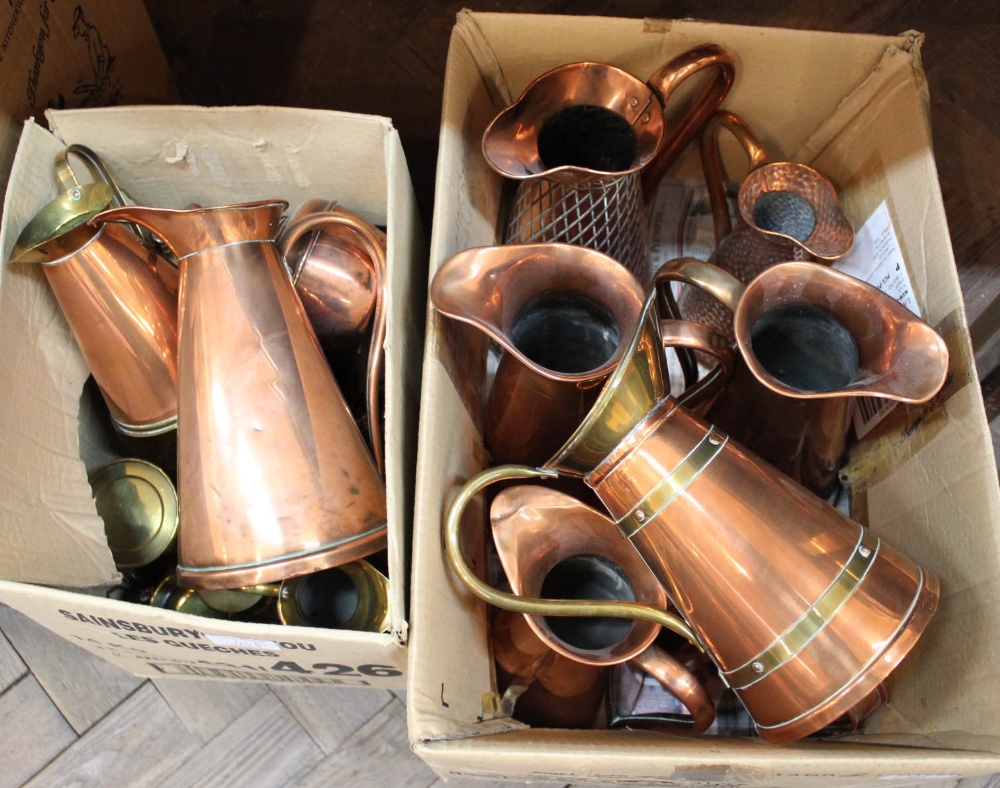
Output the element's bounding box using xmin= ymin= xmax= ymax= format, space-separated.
xmin=679 ymin=110 xmax=854 ymax=341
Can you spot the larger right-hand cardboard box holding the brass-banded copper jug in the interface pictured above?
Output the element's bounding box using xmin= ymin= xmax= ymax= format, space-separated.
xmin=407 ymin=12 xmax=1000 ymax=786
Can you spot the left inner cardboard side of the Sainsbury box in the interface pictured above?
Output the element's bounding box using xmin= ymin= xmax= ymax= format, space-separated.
xmin=0 ymin=121 xmax=116 ymax=586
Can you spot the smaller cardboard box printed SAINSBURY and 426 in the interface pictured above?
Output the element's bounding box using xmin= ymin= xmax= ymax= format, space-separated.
xmin=0 ymin=106 xmax=424 ymax=688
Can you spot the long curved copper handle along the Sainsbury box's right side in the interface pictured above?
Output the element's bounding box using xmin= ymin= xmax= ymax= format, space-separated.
xmin=279 ymin=207 xmax=386 ymax=476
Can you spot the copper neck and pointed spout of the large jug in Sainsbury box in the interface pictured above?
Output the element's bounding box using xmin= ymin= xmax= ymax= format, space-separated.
xmin=91 ymin=200 xmax=288 ymax=260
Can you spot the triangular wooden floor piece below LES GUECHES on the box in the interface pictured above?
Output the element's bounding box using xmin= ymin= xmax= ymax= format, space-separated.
xmin=153 ymin=679 xmax=269 ymax=741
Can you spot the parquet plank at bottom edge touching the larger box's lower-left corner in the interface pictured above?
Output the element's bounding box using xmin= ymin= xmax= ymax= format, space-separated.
xmin=298 ymin=699 xmax=440 ymax=788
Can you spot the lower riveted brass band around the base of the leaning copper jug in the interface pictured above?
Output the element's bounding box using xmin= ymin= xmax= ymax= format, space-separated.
xmin=724 ymin=528 xmax=879 ymax=690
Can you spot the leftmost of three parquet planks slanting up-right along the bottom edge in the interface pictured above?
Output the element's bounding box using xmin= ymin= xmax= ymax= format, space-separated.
xmin=27 ymin=683 xmax=201 ymax=788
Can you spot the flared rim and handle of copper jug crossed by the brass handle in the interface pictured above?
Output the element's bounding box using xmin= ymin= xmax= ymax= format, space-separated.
xmin=490 ymin=485 xmax=715 ymax=734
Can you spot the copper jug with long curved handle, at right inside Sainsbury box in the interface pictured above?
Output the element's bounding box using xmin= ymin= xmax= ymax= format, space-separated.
xmin=280 ymin=207 xmax=386 ymax=473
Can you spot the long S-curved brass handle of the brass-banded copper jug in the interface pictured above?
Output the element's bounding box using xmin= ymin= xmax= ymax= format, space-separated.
xmin=444 ymin=465 xmax=704 ymax=651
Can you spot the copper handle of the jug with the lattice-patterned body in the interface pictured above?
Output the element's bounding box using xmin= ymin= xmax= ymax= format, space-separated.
xmin=642 ymin=44 xmax=736 ymax=202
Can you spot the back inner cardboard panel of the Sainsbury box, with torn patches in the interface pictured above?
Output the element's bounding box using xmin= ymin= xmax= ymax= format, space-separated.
xmin=46 ymin=106 xmax=392 ymax=226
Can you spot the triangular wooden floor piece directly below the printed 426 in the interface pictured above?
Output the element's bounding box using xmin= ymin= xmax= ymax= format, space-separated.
xmin=271 ymin=684 xmax=393 ymax=755
